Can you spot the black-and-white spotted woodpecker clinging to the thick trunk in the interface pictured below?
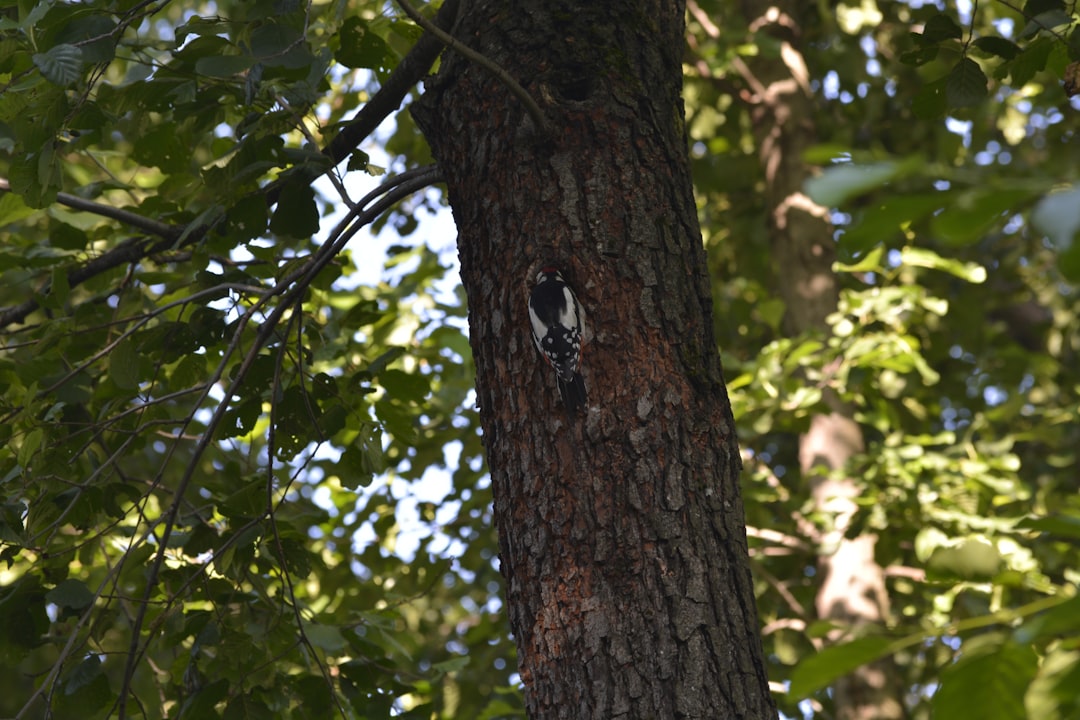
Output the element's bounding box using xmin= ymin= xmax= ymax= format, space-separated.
xmin=529 ymin=266 xmax=589 ymax=416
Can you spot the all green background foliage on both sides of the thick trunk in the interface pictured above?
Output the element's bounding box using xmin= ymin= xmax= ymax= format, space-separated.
xmin=0 ymin=0 xmax=1080 ymax=720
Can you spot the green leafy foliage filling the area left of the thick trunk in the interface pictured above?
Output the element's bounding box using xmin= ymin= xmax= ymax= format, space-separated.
xmin=0 ymin=2 xmax=521 ymax=718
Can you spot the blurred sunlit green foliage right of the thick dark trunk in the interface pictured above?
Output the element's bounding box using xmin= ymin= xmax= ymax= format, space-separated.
xmin=687 ymin=2 xmax=1080 ymax=718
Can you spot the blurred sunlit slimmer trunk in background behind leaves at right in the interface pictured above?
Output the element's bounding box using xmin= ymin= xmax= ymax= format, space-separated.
xmin=742 ymin=0 xmax=905 ymax=720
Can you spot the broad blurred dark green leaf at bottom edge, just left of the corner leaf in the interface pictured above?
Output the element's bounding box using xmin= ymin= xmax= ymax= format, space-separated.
xmin=931 ymin=642 xmax=1039 ymax=720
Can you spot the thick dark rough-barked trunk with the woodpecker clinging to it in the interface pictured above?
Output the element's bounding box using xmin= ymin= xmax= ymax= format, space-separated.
xmin=414 ymin=0 xmax=777 ymax=720
